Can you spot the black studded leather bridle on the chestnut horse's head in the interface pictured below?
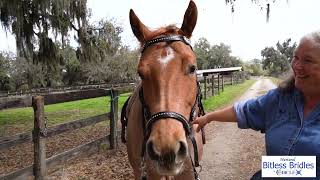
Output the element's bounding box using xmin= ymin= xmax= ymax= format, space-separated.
xmin=139 ymin=35 xmax=204 ymax=179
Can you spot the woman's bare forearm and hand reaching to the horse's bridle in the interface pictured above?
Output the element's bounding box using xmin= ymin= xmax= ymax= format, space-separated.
xmin=192 ymin=105 xmax=237 ymax=132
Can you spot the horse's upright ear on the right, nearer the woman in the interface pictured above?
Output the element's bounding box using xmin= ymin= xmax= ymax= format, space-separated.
xmin=180 ymin=0 xmax=198 ymax=38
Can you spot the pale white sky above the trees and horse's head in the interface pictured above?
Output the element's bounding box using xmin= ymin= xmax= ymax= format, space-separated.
xmin=0 ymin=0 xmax=320 ymax=61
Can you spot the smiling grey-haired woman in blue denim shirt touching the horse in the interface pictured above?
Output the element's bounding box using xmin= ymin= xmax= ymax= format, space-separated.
xmin=194 ymin=31 xmax=320 ymax=179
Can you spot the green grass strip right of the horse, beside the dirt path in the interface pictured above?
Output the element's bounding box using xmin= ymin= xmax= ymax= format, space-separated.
xmin=203 ymin=80 xmax=256 ymax=112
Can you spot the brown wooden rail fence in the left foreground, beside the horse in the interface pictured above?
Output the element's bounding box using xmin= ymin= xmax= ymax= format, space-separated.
xmin=0 ymin=86 xmax=133 ymax=180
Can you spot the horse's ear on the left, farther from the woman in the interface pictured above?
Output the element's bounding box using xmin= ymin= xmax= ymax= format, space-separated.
xmin=129 ymin=9 xmax=150 ymax=43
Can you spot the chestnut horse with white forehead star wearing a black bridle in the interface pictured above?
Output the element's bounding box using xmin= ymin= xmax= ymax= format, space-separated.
xmin=121 ymin=1 xmax=204 ymax=180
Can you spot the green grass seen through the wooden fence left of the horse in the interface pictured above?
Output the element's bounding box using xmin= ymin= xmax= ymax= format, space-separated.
xmin=0 ymin=93 xmax=130 ymax=136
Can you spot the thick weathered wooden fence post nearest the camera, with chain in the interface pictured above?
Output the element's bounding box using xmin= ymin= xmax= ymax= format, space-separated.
xmin=32 ymin=96 xmax=47 ymax=180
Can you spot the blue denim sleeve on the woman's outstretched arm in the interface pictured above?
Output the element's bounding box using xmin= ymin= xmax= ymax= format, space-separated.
xmin=233 ymin=90 xmax=278 ymax=132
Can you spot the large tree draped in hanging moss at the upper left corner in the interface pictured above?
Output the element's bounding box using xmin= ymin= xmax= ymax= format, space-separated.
xmin=0 ymin=0 xmax=88 ymax=87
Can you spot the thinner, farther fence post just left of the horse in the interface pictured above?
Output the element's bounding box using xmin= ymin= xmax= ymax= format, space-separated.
xmin=110 ymin=89 xmax=119 ymax=149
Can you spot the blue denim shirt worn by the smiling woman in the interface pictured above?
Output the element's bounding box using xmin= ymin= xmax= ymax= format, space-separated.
xmin=234 ymin=89 xmax=320 ymax=179
